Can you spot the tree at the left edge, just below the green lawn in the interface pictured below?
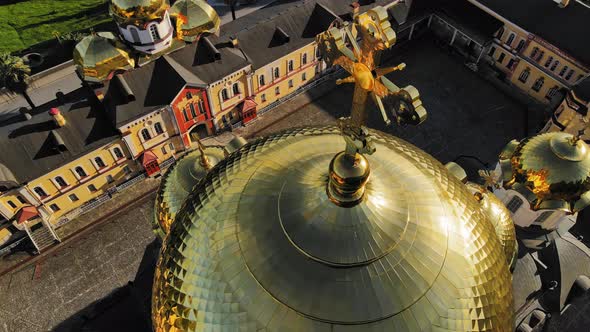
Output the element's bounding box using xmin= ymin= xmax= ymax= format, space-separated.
xmin=0 ymin=53 xmax=35 ymax=108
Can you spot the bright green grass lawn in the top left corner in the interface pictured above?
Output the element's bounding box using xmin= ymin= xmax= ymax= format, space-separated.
xmin=0 ymin=0 xmax=110 ymax=52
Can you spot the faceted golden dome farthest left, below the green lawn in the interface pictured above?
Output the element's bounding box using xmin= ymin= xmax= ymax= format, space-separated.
xmin=74 ymin=32 xmax=135 ymax=82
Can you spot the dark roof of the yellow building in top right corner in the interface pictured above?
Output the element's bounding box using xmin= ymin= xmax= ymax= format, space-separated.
xmin=478 ymin=0 xmax=590 ymax=65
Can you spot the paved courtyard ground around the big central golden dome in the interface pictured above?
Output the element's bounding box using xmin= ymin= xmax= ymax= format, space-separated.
xmin=0 ymin=35 xmax=546 ymax=332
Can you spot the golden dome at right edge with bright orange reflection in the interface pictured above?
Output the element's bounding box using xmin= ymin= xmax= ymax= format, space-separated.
xmin=500 ymin=132 xmax=590 ymax=213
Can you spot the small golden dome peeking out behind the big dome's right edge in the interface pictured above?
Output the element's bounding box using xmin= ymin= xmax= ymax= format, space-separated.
xmin=467 ymin=182 xmax=518 ymax=269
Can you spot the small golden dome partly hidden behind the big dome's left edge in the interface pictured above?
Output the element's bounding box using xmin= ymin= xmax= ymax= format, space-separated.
xmin=154 ymin=146 xmax=225 ymax=239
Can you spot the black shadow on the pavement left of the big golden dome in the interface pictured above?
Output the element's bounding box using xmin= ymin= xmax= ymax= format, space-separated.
xmin=53 ymin=239 xmax=161 ymax=332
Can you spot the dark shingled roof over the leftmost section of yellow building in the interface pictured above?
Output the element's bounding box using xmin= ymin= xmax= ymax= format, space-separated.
xmin=0 ymin=89 xmax=118 ymax=183
